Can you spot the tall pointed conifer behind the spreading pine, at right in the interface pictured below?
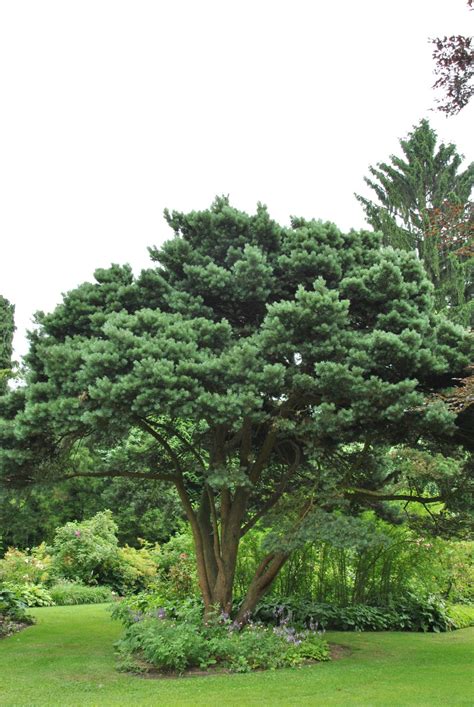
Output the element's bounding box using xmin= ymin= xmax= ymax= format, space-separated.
xmin=356 ymin=120 xmax=474 ymax=324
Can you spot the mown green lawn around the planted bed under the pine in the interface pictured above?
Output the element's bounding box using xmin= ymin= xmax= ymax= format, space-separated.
xmin=0 ymin=604 xmax=474 ymax=707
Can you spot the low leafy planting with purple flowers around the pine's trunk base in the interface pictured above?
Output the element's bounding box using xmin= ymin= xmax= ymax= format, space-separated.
xmin=112 ymin=599 xmax=329 ymax=673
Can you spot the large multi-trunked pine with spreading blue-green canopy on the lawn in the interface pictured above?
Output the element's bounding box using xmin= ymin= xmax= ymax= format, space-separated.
xmin=0 ymin=198 xmax=471 ymax=618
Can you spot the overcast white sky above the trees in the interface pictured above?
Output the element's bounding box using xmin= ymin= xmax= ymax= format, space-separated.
xmin=0 ymin=0 xmax=474 ymax=354
